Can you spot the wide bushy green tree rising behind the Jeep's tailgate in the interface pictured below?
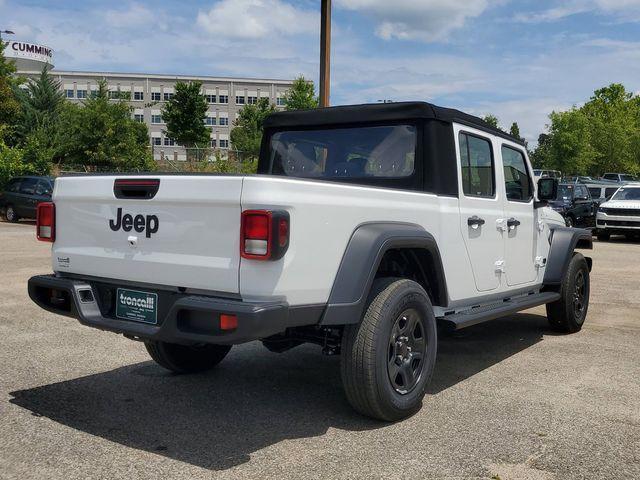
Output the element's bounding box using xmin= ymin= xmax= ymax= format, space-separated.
xmin=60 ymin=81 xmax=155 ymax=171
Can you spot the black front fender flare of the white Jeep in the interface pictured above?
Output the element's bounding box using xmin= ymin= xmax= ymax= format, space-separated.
xmin=542 ymin=226 xmax=593 ymax=286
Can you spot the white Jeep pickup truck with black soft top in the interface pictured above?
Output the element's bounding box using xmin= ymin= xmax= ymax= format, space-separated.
xmin=29 ymin=102 xmax=592 ymax=421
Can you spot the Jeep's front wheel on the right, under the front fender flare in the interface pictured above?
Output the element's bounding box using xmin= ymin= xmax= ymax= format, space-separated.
xmin=547 ymin=253 xmax=590 ymax=333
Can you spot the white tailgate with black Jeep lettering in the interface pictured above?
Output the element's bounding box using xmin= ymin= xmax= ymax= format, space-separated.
xmin=52 ymin=175 xmax=243 ymax=293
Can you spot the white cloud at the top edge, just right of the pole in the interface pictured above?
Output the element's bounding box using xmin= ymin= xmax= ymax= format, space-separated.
xmin=336 ymin=0 xmax=501 ymax=42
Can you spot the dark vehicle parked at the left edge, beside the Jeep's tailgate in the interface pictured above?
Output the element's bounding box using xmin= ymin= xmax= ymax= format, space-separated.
xmin=0 ymin=176 xmax=54 ymax=222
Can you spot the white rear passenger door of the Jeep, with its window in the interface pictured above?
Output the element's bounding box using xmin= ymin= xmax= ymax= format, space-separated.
xmin=454 ymin=126 xmax=504 ymax=292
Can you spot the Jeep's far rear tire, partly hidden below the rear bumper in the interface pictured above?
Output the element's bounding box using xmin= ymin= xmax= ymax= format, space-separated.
xmin=144 ymin=340 xmax=231 ymax=373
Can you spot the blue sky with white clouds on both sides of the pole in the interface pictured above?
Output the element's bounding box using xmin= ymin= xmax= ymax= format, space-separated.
xmin=0 ymin=0 xmax=640 ymax=141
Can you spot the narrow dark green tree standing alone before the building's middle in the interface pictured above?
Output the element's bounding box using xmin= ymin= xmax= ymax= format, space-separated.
xmin=162 ymin=82 xmax=209 ymax=159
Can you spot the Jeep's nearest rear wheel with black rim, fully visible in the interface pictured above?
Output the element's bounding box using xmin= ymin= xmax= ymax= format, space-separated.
xmin=341 ymin=278 xmax=437 ymax=422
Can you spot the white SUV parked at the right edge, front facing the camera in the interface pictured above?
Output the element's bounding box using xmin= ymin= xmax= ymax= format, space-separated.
xmin=596 ymin=183 xmax=640 ymax=240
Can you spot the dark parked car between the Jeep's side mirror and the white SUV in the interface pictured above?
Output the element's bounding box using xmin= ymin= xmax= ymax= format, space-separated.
xmin=549 ymin=183 xmax=598 ymax=228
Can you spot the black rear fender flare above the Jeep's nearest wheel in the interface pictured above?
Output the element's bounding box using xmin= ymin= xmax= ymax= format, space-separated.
xmin=320 ymin=222 xmax=448 ymax=325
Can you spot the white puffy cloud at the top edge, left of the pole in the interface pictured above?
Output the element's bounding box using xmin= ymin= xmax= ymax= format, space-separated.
xmin=197 ymin=0 xmax=319 ymax=39
